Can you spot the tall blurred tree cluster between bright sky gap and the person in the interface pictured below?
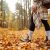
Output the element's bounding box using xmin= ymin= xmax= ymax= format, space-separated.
xmin=16 ymin=0 xmax=31 ymax=29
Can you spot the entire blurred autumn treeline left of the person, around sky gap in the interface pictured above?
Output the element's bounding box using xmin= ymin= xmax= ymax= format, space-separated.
xmin=0 ymin=0 xmax=31 ymax=30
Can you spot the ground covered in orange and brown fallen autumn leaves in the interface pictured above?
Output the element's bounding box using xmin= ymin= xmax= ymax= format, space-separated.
xmin=0 ymin=28 xmax=50 ymax=50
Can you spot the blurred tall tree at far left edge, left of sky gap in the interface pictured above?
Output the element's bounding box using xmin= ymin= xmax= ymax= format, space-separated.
xmin=0 ymin=0 xmax=9 ymax=27
